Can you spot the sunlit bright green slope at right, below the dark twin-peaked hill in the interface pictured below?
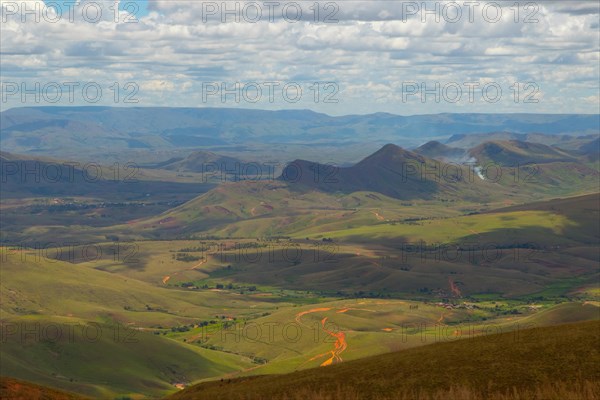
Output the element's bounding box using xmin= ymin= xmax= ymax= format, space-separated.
xmin=295 ymin=194 xmax=600 ymax=245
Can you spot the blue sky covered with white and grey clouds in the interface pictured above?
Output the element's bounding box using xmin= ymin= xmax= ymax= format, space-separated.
xmin=0 ymin=0 xmax=600 ymax=115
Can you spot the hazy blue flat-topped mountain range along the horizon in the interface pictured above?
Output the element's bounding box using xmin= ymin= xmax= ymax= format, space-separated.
xmin=0 ymin=107 xmax=600 ymax=157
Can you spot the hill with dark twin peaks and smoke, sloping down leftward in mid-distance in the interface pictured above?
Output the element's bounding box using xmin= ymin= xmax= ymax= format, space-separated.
xmin=99 ymin=141 xmax=600 ymax=244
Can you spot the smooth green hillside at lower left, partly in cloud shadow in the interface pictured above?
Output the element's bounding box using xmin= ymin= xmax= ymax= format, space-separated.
xmin=0 ymin=248 xmax=292 ymax=398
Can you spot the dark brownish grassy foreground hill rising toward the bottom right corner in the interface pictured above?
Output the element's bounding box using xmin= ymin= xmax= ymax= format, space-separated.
xmin=169 ymin=321 xmax=600 ymax=400
